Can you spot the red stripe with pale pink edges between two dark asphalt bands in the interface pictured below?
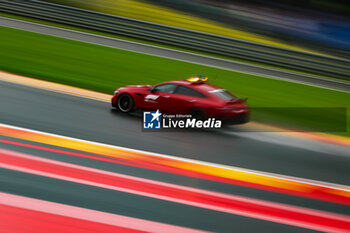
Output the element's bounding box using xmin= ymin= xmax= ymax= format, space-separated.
xmin=0 ymin=149 xmax=350 ymax=231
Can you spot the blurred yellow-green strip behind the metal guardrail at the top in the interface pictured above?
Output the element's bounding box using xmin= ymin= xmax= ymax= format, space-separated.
xmin=41 ymin=0 xmax=312 ymax=52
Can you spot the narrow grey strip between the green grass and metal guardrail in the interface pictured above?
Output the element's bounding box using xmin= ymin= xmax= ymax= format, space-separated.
xmin=0 ymin=17 xmax=350 ymax=92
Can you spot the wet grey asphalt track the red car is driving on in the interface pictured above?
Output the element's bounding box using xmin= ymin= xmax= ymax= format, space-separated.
xmin=0 ymin=82 xmax=350 ymax=185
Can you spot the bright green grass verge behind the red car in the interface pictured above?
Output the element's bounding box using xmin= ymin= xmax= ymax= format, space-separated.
xmin=0 ymin=27 xmax=350 ymax=135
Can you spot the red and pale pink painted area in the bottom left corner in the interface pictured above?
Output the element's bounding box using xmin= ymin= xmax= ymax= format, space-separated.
xmin=0 ymin=192 xmax=203 ymax=233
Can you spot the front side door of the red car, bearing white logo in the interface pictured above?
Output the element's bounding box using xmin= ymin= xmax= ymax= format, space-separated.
xmin=144 ymin=84 xmax=177 ymax=111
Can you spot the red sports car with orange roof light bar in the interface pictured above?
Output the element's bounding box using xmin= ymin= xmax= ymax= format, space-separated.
xmin=112 ymin=77 xmax=250 ymax=124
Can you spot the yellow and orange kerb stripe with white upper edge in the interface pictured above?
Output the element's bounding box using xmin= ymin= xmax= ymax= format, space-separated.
xmin=0 ymin=124 xmax=350 ymax=205
